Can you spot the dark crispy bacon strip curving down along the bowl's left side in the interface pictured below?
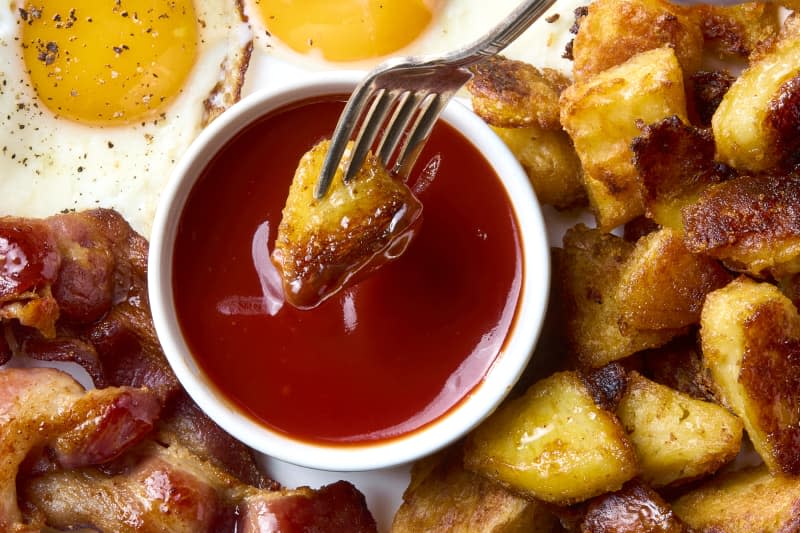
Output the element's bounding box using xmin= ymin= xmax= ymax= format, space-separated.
xmin=0 ymin=209 xmax=268 ymax=488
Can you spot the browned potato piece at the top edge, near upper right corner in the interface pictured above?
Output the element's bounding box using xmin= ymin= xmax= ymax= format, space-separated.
xmin=692 ymin=2 xmax=780 ymax=58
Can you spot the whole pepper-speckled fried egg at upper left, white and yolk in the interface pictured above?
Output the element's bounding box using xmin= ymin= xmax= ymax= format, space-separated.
xmin=0 ymin=0 xmax=252 ymax=235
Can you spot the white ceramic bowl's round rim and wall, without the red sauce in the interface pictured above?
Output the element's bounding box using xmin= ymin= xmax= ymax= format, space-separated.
xmin=148 ymin=71 xmax=550 ymax=471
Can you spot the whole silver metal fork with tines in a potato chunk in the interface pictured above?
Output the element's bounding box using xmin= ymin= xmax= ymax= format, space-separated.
xmin=314 ymin=0 xmax=555 ymax=199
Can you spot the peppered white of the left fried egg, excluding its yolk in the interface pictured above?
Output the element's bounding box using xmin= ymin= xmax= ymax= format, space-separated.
xmin=0 ymin=0 xmax=252 ymax=236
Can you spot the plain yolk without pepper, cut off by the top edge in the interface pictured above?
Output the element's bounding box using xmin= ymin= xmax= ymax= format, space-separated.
xmin=255 ymin=0 xmax=432 ymax=61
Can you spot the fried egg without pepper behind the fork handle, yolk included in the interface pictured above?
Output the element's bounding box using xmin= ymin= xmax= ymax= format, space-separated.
xmin=245 ymin=0 xmax=585 ymax=73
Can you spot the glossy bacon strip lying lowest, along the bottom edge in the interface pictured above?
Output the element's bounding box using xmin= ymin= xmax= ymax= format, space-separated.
xmin=21 ymin=443 xmax=376 ymax=533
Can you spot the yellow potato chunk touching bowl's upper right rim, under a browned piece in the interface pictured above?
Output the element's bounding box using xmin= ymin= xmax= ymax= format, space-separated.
xmin=492 ymin=126 xmax=586 ymax=209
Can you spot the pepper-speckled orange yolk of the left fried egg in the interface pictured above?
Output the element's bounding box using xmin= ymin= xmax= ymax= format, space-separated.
xmin=19 ymin=0 xmax=197 ymax=125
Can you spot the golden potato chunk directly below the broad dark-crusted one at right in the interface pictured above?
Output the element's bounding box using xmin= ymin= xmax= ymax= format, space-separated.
xmin=613 ymin=228 xmax=732 ymax=334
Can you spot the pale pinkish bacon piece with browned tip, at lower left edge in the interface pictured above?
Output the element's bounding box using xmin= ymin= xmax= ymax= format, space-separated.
xmin=0 ymin=368 xmax=160 ymax=531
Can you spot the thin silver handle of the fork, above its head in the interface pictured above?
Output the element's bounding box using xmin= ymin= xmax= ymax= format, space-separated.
xmin=440 ymin=0 xmax=555 ymax=67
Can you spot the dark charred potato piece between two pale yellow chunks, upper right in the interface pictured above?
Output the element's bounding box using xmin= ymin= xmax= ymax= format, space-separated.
xmin=631 ymin=116 xmax=726 ymax=230
